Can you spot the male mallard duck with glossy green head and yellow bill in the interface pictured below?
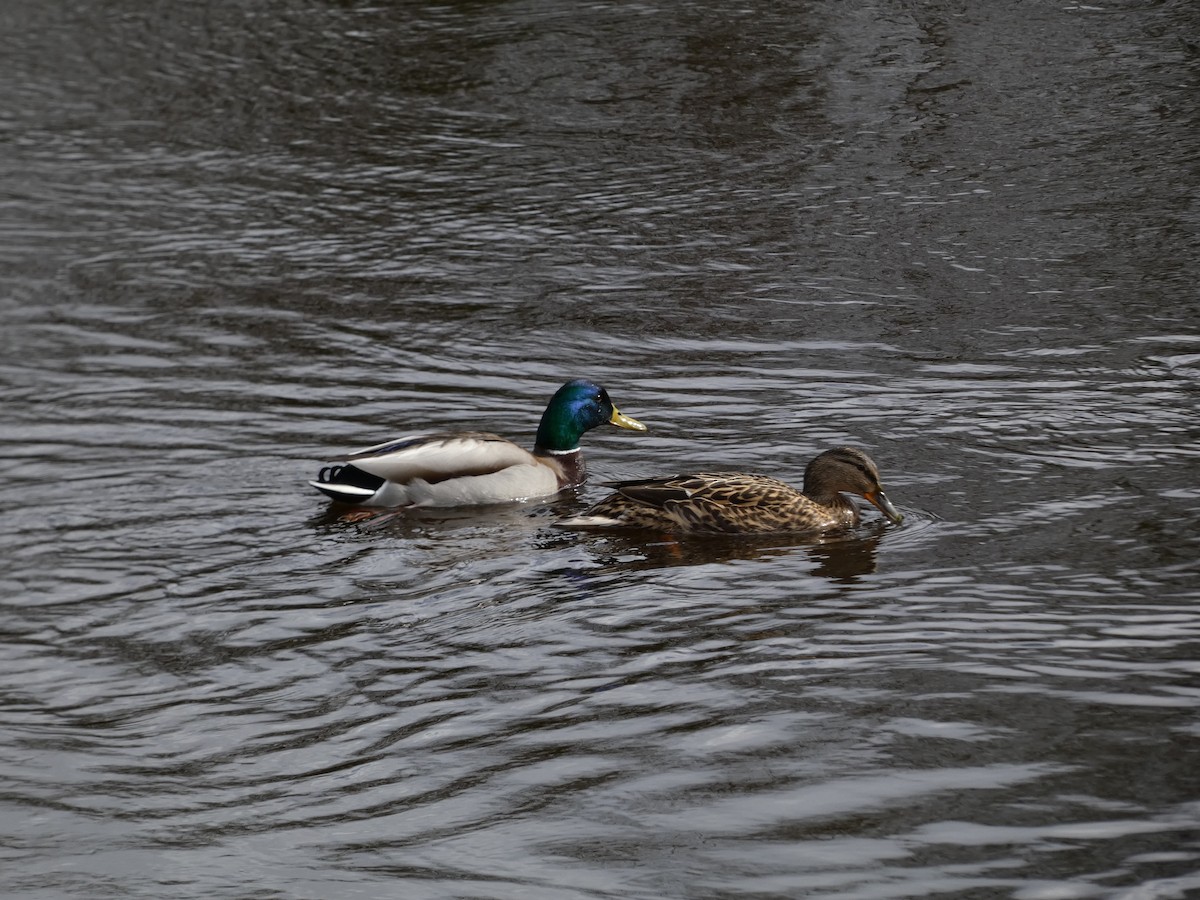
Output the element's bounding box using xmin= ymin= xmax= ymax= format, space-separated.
xmin=308 ymin=378 xmax=646 ymax=506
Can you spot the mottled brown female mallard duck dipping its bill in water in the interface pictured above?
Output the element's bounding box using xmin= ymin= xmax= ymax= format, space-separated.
xmin=559 ymin=446 xmax=904 ymax=534
